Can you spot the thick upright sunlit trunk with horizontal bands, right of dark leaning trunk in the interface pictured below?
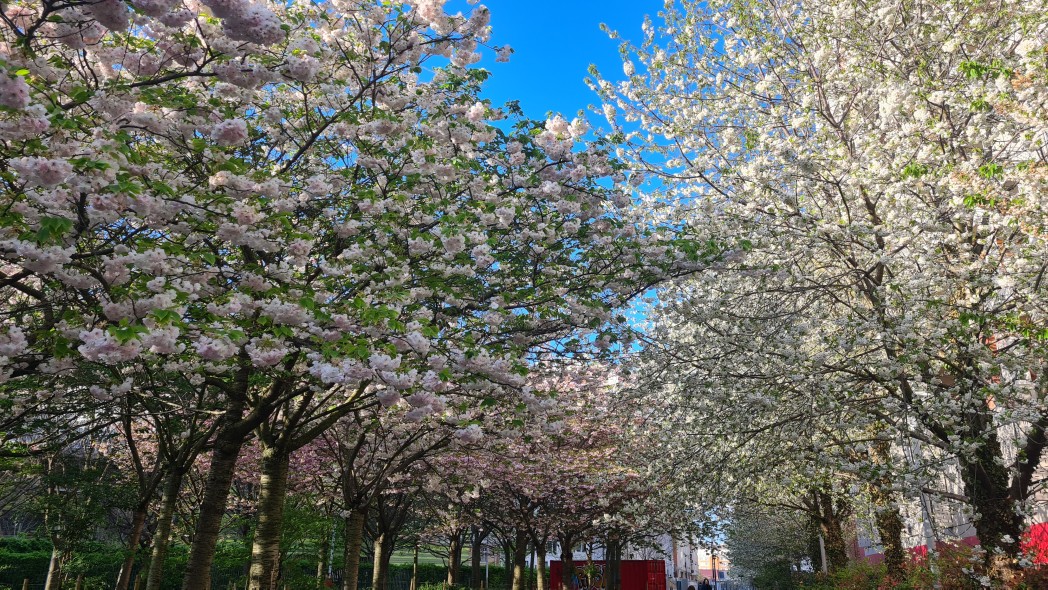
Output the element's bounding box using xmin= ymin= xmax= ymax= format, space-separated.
xmin=247 ymin=445 xmax=290 ymax=590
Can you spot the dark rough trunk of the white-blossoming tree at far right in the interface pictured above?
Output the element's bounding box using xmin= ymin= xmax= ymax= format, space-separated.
xmin=958 ymin=425 xmax=1023 ymax=584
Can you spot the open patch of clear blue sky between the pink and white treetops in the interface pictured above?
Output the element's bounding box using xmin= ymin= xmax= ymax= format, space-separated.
xmin=445 ymin=0 xmax=662 ymax=119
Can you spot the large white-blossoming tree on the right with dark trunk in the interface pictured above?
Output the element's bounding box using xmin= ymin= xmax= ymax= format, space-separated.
xmin=593 ymin=0 xmax=1048 ymax=581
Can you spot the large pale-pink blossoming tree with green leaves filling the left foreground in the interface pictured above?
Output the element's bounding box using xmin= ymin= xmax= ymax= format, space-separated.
xmin=0 ymin=0 xmax=717 ymax=589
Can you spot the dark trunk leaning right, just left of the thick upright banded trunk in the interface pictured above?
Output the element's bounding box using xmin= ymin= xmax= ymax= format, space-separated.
xmin=182 ymin=429 xmax=244 ymax=590
